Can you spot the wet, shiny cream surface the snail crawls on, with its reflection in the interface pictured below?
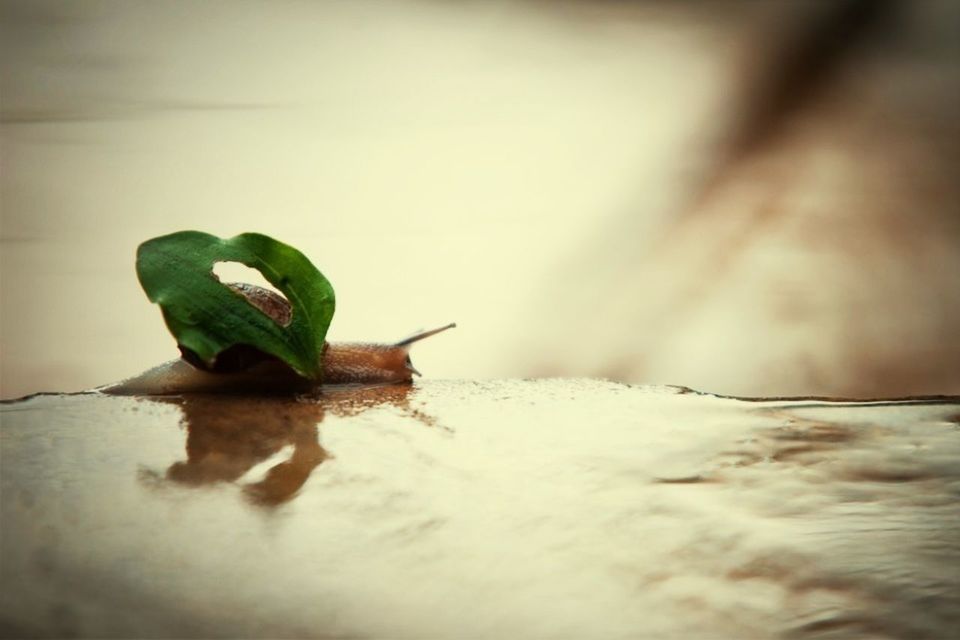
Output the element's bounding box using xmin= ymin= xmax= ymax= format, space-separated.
xmin=0 ymin=380 xmax=960 ymax=638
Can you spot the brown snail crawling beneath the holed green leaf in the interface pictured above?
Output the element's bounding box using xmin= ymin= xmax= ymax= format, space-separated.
xmin=98 ymin=282 xmax=457 ymax=395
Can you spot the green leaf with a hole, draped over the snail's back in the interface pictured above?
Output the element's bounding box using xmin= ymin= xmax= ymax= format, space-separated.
xmin=137 ymin=231 xmax=335 ymax=380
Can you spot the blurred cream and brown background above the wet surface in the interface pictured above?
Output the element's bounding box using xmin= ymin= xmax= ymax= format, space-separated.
xmin=0 ymin=0 xmax=960 ymax=398
